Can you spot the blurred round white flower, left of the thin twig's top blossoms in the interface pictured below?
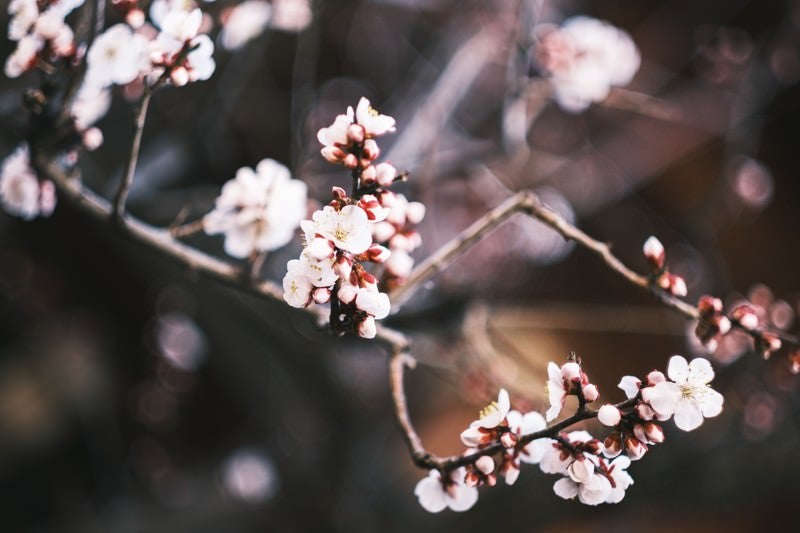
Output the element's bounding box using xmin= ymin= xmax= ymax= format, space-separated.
xmin=86 ymin=23 xmax=148 ymax=88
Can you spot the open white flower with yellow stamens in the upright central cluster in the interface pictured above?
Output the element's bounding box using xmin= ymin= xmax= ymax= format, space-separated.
xmin=301 ymin=205 xmax=372 ymax=255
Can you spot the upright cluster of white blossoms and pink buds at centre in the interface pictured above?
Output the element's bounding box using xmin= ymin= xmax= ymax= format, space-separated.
xmin=283 ymin=98 xmax=424 ymax=338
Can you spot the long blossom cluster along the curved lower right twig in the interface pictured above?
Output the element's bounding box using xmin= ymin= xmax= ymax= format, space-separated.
xmin=414 ymin=355 xmax=723 ymax=512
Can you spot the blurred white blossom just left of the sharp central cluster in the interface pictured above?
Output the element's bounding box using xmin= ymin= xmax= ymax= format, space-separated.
xmin=203 ymin=159 xmax=306 ymax=258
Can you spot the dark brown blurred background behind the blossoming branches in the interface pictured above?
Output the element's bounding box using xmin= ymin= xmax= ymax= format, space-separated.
xmin=0 ymin=0 xmax=800 ymax=533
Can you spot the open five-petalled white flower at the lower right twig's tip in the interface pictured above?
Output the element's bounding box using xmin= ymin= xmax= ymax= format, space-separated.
xmin=642 ymin=355 xmax=724 ymax=431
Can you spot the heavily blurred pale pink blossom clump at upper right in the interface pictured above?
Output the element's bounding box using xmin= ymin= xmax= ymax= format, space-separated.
xmin=536 ymin=17 xmax=640 ymax=113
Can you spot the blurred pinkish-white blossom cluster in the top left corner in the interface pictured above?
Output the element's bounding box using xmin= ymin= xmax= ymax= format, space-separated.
xmin=5 ymin=0 xmax=84 ymax=78
